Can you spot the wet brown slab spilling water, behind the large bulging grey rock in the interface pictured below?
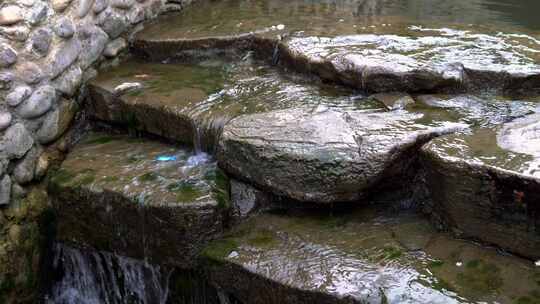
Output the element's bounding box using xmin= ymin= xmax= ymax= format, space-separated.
xmin=87 ymin=57 xmax=383 ymax=151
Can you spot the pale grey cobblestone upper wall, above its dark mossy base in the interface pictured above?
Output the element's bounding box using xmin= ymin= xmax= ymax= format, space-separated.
xmin=0 ymin=0 xmax=173 ymax=206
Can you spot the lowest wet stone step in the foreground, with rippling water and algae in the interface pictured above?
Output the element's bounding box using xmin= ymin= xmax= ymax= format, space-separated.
xmin=201 ymin=207 xmax=538 ymax=304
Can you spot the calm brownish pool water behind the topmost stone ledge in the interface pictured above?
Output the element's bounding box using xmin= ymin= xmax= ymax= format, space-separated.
xmin=143 ymin=0 xmax=540 ymax=39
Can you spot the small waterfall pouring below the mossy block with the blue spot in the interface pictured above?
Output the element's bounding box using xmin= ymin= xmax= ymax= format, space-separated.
xmin=45 ymin=244 xmax=171 ymax=304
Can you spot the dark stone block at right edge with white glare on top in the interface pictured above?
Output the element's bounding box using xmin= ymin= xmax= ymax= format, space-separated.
xmin=422 ymin=114 xmax=540 ymax=259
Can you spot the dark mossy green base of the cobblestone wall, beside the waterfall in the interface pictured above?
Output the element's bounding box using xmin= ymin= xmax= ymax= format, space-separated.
xmin=0 ymin=185 xmax=54 ymax=303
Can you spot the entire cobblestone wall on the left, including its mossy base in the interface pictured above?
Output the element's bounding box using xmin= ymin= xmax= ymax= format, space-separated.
xmin=0 ymin=0 xmax=182 ymax=303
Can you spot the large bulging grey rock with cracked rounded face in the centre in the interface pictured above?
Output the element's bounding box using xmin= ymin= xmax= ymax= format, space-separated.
xmin=217 ymin=106 xmax=460 ymax=203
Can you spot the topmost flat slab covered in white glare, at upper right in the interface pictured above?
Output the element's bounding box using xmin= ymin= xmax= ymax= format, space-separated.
xmin=280 ymin=32 xmax=540 ymax=95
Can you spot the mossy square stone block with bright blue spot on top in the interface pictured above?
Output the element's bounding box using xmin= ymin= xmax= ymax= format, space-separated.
xmin=49 ymin=133 xmax=229 ymax=267
